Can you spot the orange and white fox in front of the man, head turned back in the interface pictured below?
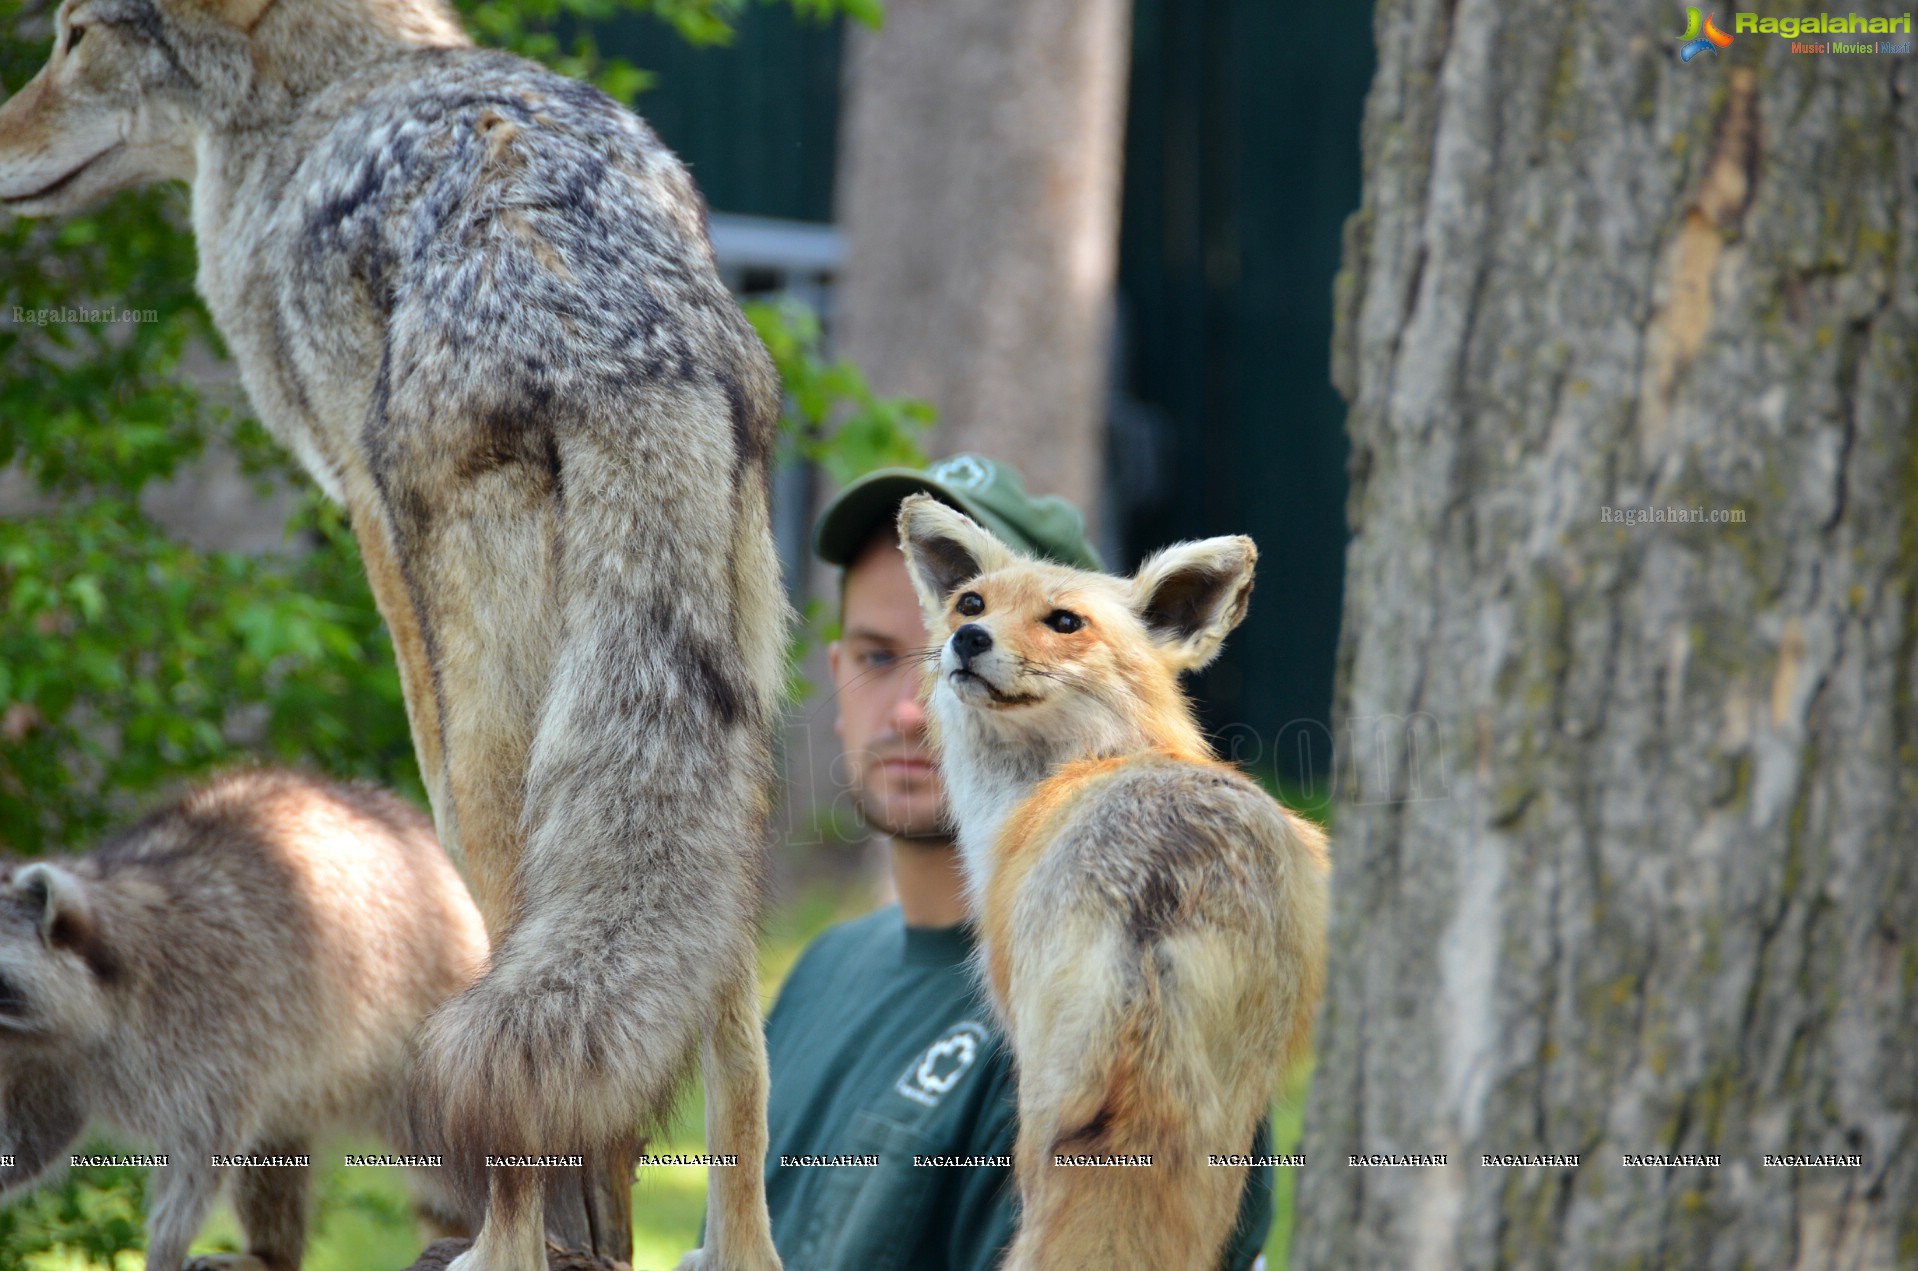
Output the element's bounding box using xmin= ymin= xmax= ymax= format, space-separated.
xmin=900 ymin=495 xmax=1327 ymax=1271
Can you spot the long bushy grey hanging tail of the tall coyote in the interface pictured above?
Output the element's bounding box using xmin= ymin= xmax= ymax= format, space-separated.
xmin=412 ymin=387 xmax=786 ymax=1200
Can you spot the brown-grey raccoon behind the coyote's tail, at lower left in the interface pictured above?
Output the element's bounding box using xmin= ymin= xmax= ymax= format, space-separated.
xmin=0 ymin=771 xmax=485 ymax=1271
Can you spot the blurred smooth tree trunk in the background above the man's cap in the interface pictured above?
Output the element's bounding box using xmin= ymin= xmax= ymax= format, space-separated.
xmin=834 ymin=0 xmax=1130 ymax=514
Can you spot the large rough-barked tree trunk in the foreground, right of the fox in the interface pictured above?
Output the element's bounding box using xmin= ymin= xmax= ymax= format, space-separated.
xmin=1293 ymin=0 xmax=1918 ymax=1269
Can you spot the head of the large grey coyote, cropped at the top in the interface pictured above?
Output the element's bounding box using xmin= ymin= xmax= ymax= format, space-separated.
xmin=0 ymin=0 xmax=466 ymax=217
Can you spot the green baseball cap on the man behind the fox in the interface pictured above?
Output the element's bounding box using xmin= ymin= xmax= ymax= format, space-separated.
xmin=813 ymin=454 xmax=1105 ymax=569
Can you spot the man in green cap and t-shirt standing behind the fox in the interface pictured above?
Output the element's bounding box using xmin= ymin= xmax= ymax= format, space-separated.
xmin=765 ymin=454 xmax=1272 ymax=1271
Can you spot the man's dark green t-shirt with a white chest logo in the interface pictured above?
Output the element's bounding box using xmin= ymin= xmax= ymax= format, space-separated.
xmin=765 ymin=905 xmax=1272 ymax=1271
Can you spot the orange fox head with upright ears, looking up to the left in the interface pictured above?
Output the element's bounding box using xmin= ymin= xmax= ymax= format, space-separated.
xmin=900 ymin=495 xmax=1258 ymax=763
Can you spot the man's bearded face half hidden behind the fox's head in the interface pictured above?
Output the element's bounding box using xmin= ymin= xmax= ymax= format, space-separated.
xmin=827 ymin=535 xmax=949 ymax=838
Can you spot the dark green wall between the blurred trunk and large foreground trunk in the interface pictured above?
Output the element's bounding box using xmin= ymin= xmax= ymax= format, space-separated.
xmin=1120 ymin=0 xmax=1373 ymax=780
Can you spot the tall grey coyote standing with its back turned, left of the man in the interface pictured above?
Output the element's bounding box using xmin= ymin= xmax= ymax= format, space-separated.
xmin=0 ymin=0 xmax=788 ymax=1271
